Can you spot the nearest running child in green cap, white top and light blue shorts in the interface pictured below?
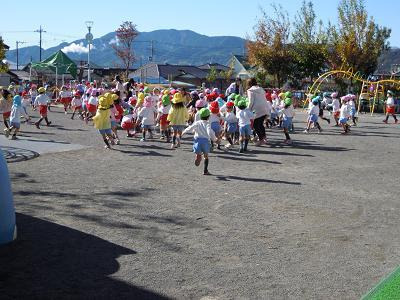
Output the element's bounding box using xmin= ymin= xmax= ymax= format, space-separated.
xmin=182 ymin=108 xmax=216 ymax=175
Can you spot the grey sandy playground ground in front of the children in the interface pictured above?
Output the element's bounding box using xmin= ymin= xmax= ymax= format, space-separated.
xmin=0 ymin=108 xmax=400 ymax=299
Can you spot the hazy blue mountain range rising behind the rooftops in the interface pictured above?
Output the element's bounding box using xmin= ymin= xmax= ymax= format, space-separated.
xmin=6 ymin=29 xmax=246 ymax=67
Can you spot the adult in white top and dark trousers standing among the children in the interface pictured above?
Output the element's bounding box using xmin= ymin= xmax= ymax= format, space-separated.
xmin=247 ymin=78 xmax=268 ymax=146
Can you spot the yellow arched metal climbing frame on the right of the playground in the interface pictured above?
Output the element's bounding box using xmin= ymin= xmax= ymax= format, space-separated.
xmin=308 ymin=68 xmax=400 ymax=115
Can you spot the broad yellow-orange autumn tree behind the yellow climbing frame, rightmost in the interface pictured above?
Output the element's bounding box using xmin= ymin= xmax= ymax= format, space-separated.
xmin=328 ymin=0 xmax=391 ymax=76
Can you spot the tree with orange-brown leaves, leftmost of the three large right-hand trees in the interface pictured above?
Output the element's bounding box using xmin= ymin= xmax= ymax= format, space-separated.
xmin=247 ymin=5 xmax=293 ymax=86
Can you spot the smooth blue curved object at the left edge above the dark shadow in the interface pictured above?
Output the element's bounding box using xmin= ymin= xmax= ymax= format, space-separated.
xmin=0 ymin=150 xmax=17 ymax=245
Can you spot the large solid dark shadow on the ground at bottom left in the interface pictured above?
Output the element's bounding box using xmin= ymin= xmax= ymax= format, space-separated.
xmin=0 ymin=214 xmax=168 ymax=299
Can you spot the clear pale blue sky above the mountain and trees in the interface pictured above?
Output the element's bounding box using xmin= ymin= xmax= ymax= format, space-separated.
xmin=0 ymin=0 xmax=400 ymax=48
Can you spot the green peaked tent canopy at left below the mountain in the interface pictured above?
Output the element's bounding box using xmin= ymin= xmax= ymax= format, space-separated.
xmin=32 ymin=50 xmax=77 ymax=78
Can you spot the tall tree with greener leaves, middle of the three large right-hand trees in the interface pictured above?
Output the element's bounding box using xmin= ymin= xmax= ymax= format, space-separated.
xmin=292 ymin=0 xmax=328 ymax=80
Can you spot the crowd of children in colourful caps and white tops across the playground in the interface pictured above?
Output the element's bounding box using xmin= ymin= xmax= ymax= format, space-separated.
xmin=0 ymin=84 xmax=397 ymax=175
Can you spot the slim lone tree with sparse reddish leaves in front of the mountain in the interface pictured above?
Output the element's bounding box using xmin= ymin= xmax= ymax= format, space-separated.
xmin=111 ymin=21 xmax=139 ymax=77
